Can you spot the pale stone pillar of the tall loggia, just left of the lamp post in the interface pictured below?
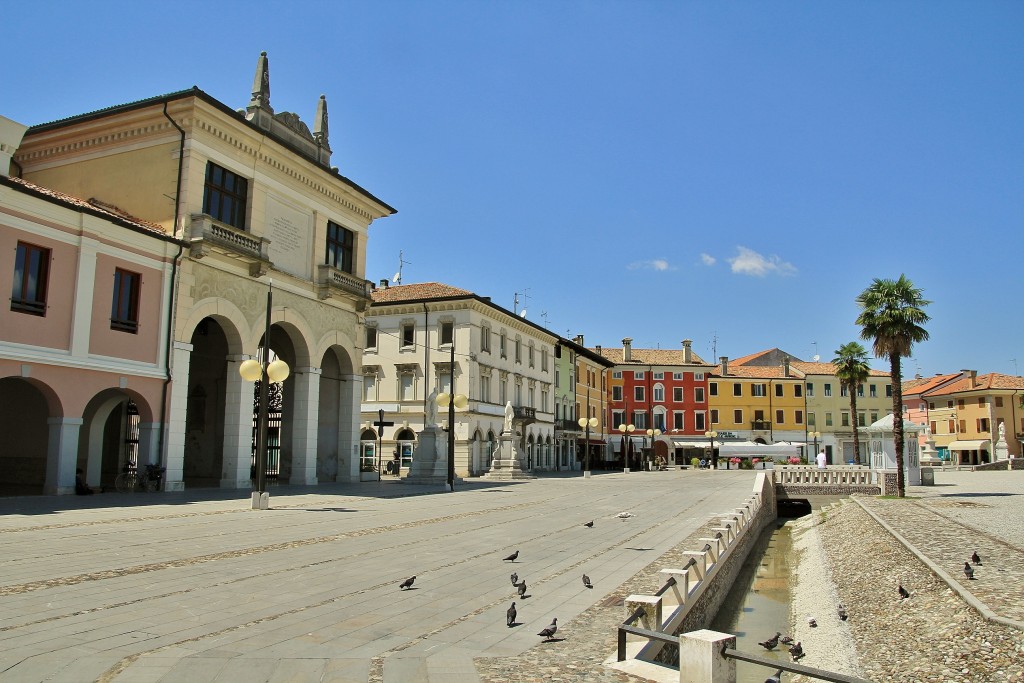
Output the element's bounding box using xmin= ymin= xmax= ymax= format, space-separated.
xmin=220 ymin=355 xmax=253 ymax=488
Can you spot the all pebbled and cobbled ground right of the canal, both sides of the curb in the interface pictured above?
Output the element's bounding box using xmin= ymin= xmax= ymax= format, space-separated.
xmin=787 ymin=472 xmax=1024 ymax=683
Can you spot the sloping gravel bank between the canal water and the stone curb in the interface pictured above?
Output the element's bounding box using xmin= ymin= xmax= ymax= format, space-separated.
xmin=786 ymin=502 xmax=1024 ymax=683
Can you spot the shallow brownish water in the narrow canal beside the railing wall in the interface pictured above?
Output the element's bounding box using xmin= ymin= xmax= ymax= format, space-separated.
xmin=710 ymin=517 xmax=796 ymax=683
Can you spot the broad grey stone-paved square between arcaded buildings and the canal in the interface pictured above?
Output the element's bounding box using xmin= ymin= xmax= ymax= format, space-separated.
xmin=0 ymin=471 xmax=753 ymax=683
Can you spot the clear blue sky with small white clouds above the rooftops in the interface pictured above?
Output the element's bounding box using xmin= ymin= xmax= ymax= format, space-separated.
xmin=8 ymin=0 xmax=1024 ymax=375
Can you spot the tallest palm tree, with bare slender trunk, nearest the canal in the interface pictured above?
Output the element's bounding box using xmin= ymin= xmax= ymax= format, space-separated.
xmin=857 ymin=274 xmax=931 ymax=498
